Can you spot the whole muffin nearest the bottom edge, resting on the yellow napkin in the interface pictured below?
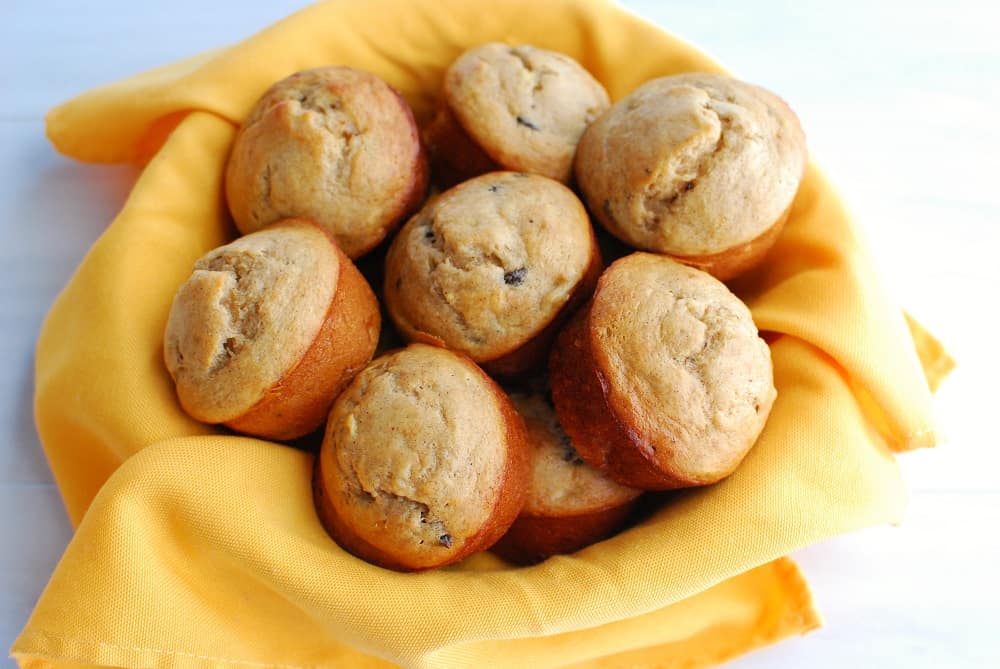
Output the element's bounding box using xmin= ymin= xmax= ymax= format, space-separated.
xmin=314 ymin=344 xmax=529 ymax=571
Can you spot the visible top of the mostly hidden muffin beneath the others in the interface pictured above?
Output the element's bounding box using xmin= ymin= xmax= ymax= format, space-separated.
xmin=510 ymin=393 xmax=642 ymax=516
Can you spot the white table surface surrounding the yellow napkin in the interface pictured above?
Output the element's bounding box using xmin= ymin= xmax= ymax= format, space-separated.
xmin=0 ymin=0 xmax=1000 ymax=669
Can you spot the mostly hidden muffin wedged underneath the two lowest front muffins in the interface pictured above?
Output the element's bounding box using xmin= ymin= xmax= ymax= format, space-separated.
xmin=493 ymin=393 xmax=642 ymax=564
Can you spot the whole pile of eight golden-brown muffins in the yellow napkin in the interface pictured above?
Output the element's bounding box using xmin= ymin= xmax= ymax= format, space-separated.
xmin=164 ymin=44 xmax=806 ymax=570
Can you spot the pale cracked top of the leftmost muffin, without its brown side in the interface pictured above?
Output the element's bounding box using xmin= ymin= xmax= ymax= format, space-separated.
xmin=163 ymin=220 xmax=340 ymax=423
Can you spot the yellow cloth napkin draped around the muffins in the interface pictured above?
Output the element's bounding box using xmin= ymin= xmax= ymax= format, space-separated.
xmin=12 ymin=0 xmax=950 ymax=669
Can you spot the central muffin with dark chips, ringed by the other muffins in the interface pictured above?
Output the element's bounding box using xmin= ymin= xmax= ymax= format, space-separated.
xmin=384 ymin=172 xmax=601 ymax=375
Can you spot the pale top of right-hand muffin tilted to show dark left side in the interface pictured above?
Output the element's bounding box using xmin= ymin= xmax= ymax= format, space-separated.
xmin=589 ymin=253 xmax=777 ymax=481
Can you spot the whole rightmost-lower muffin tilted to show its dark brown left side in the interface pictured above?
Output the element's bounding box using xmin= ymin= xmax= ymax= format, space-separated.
xmin=550 ymin=253 xmax=777 ymax=490
